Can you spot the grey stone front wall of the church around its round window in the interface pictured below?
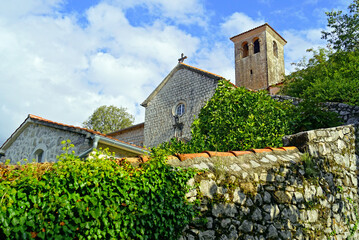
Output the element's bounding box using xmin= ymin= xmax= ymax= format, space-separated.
xmin=144 ymin=68 xmax=218 ymax=147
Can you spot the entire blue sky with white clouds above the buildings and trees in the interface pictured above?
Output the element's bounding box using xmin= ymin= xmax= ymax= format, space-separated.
xmin=0 ymin=0 xmax=350 ymax=145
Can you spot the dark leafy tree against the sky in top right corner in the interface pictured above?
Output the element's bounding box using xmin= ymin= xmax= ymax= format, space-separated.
xmin=322 ymin=0 xmax=359 ymax=51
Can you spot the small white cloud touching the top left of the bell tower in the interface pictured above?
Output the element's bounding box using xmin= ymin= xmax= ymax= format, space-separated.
xmin=221 ymin=12 xmax=265 ymax=37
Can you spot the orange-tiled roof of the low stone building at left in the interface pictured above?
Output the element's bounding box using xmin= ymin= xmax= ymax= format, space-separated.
xmin=0 ymin=114 xmax=149 ymax=154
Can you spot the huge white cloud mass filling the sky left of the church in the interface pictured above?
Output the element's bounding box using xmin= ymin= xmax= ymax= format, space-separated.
xmin=0 ymin=1 xmax=199 ymax=144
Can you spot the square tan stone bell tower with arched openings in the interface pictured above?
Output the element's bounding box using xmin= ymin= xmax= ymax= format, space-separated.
xmin=231 ymin=23 xmax=287 ymax=93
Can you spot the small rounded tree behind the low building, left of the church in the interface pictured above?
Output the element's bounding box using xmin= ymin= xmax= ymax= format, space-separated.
xmin=83 ymin=105 xmax=134 ymax=134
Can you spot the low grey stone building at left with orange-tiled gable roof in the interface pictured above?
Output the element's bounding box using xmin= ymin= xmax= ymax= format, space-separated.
xmin=0 ymin=114 xmax=148 ymax=163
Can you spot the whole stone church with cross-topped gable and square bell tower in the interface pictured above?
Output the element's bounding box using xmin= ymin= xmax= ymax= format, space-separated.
xmin=108 ymin=23 xmax=287 ymax=147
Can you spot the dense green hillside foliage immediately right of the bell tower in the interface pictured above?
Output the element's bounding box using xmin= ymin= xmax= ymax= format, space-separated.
xmin=282 ymin=49 xmax=359 ymax=105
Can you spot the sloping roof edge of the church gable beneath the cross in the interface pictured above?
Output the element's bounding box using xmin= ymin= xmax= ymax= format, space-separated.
xmin=141 ymin=62 xmax=223 ymax=107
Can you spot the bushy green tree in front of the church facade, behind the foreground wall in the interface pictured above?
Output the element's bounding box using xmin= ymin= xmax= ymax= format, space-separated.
xmin=152 ymin=80 xmax=298 ymax=153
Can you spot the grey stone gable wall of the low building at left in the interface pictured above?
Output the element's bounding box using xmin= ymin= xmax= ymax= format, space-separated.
xmin=1 ymin=124 xmax=92 ymax=163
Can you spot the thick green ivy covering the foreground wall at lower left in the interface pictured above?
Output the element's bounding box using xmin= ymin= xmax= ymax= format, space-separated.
xmin=0 ymin=142 xmax=196 ymax=239
